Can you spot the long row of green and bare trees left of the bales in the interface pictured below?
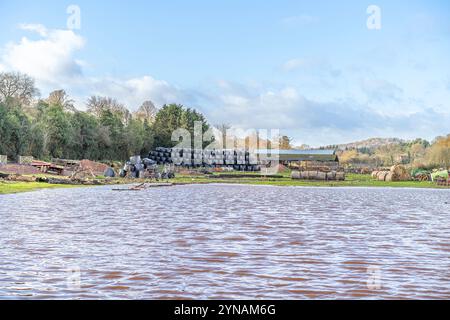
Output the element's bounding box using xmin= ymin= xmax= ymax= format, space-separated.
xmin=0 ymin=73 xmax=209 ymax=160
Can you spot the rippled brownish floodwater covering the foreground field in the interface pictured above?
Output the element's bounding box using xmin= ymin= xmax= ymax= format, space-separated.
xmin=0 ymin=185 xmax=450 ymax=299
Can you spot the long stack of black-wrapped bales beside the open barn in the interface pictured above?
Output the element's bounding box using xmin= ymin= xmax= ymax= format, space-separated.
xmin=149 ymin=147 xmax=260 ymax=171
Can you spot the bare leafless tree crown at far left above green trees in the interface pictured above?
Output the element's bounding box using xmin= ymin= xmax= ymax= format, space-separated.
xmin=0 ymin=72 xmax=39 ymax=104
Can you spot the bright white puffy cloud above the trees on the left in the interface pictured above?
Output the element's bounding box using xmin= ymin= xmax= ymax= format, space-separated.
xmin=0 ymin=24 xmax=187 ymax=109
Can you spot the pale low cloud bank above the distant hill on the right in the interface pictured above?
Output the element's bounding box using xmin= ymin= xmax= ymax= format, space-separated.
xmin=202 ymin=85 xmax=450 ymax=145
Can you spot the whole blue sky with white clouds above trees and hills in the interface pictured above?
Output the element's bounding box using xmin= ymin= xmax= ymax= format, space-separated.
xmin=0 ymin=0 xmax=450 ymax=146
